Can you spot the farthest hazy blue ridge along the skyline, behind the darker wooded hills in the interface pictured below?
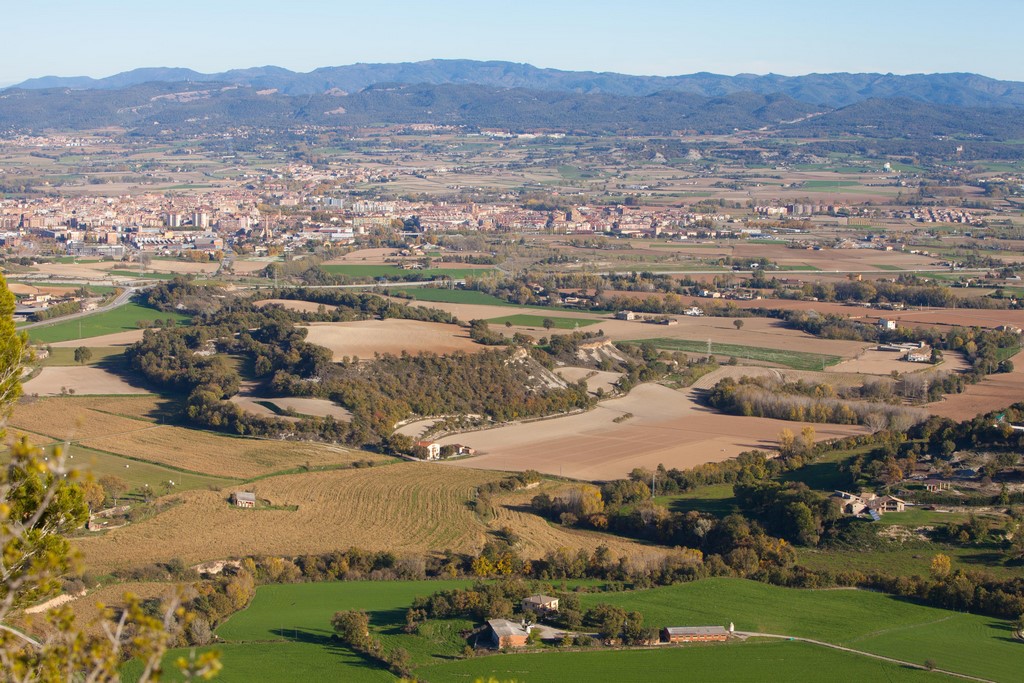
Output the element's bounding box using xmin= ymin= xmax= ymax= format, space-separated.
xmin=13 ymin=59 xmax=1024 ymax=109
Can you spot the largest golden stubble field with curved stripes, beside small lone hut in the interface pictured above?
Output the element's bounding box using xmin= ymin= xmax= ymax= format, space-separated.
xmin=75 ymin=463 xmax=644 ymax=570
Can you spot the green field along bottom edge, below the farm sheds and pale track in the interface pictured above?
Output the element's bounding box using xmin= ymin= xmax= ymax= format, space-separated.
xmin=416 ymin=641 xmax=949 ymax=683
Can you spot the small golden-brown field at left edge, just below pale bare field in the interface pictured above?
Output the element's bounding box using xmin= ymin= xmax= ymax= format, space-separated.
xmin=10 ymin=396 xmax=157 ymax=441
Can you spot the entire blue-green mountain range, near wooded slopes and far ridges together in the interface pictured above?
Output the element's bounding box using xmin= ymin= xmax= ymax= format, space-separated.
xmin=6 ymin=59 xmax=1024 ymax=145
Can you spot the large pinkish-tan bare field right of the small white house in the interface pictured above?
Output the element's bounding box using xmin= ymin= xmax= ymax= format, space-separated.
xmin=440 ymin=384 xmax=865 ymax=480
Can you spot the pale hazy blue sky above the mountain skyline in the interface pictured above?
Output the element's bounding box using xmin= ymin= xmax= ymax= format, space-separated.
xmin=8 ymin=0 xmax=1024 ymax=84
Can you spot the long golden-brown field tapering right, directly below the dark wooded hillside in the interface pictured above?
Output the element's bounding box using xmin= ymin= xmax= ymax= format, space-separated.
xmin=81 ymin=426 xmax=373 ymax=479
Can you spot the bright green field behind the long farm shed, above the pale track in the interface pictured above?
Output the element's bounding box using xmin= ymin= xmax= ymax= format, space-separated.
xmin=582 ymin=579 xmax=1024 ymax=681
